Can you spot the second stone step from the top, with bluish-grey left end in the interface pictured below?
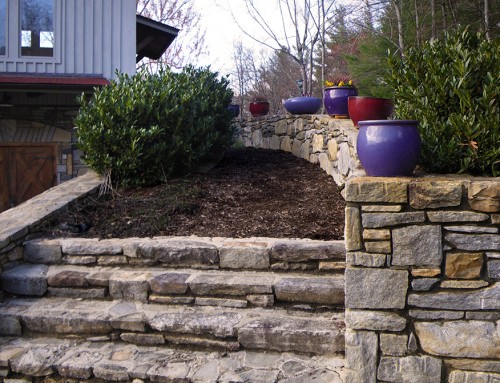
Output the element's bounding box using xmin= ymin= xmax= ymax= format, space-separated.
xmin=0 ymin=264 xmax=344 ymax=309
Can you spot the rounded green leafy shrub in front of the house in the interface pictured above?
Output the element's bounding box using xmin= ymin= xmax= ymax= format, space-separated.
xmin=75 ymin=67 xmax=233 ymax=186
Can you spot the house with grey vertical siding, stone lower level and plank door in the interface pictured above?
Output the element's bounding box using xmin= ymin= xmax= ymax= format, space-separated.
xmin=0 ymin=0 xmax=178 ymax=212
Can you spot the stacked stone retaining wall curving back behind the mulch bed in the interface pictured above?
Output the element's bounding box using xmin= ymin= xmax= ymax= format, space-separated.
xmin=238 ymin=116 xmax=500 ymax=383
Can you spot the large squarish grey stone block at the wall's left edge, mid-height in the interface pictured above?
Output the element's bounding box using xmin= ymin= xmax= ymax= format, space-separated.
xmin=345 ymin=267 xmax=408 ymax=309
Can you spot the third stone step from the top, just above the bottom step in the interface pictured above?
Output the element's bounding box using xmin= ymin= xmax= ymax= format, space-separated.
xmin=0 ymin=298 xmax=345 ymax=354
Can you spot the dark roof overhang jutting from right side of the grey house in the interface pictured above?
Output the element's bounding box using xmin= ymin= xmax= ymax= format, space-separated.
xmin=136 ymin=15 xmax=179 ymax=62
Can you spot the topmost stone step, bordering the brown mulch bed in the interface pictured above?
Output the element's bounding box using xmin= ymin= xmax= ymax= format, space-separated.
xmin=24 ymin=237 xmax=345 ymax=273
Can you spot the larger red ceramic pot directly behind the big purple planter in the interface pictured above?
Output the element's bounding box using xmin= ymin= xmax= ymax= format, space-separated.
xmin=347 ymin=96 xmax=394 ymax=127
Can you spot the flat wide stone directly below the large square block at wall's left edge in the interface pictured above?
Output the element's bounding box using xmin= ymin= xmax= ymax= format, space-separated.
xmin=345 ymin=309 xmax=406 ymax=331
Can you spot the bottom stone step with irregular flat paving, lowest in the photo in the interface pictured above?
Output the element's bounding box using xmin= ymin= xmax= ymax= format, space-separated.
xmin=0 ymin=338 xmax=346 ymax=383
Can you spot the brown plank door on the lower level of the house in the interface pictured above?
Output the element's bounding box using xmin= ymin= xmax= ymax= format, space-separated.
xmin=0 ymin=145 xmax=56 ymax=211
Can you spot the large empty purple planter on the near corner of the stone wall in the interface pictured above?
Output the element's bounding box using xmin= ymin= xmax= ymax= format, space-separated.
xmin=356 ymin=120 xmax=421 ymax=177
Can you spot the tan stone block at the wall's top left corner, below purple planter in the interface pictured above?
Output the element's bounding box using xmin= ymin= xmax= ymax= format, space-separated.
xmin=345 ymin=177 xmax=409 ymax=203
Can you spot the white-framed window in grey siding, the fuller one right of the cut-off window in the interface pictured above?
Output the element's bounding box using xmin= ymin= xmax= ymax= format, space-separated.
xmin=20 ymin=0 xmax=54 ymax=57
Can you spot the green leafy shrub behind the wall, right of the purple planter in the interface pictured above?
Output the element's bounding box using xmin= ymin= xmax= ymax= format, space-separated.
xmin=388 ymin=29 xmax=500 ymax=176
